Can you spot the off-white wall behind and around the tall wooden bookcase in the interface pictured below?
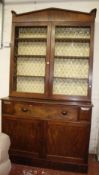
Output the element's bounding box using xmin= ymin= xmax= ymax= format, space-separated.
xmin=0 ymin=0 xmax=99 ymax=153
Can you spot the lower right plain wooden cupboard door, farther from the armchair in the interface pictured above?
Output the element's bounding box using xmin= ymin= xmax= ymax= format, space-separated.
xmin=46 ymin=121 xmax=90 ymax=163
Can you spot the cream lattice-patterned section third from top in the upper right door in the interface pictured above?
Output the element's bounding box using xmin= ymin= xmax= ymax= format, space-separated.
xmin=54 ymin=59 xmax=89 ymax=78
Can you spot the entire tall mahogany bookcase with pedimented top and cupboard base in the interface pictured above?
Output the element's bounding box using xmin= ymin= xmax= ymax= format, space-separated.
xmin=2 ymin=8 xmax=96 ymax=172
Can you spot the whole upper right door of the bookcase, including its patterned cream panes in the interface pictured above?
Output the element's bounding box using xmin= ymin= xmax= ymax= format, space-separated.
xmin=50 ymin=22 xmax=92 ymax=99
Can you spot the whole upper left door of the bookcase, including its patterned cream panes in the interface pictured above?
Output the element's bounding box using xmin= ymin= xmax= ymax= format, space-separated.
xmin=11 ymin=23 xmax=51 ymax=97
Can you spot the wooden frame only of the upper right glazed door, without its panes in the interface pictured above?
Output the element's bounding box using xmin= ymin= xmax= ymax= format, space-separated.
xmin=50 ymin=22 xmax=94 ymax=102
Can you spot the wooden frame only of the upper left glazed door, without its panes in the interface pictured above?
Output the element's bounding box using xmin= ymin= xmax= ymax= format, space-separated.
xmin=10 ymin=22 xmax=51 ymax=98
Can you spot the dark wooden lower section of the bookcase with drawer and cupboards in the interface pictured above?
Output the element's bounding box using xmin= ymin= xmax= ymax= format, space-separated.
xmin=2 ymin=98 xmax=92 ymax=173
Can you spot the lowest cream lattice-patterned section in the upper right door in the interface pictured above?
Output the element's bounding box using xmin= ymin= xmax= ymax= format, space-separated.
xmin=53 ymin=78 xmax=88 ymax=96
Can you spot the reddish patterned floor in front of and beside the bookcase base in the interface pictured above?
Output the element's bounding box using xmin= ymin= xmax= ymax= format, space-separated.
xmin=10 ymin=157 xmax=99 ymax=175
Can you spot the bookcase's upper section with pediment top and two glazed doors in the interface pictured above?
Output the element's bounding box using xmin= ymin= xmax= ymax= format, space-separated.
xmin=10 ymin=8 xmax=96 ymax=101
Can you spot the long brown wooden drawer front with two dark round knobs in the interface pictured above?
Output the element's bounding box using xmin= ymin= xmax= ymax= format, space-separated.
xmin=14 ymin=103 xmax=78 ymax=121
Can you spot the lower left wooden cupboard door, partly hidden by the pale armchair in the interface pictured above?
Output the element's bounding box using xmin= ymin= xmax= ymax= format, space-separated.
xmin=3 ymin=116 xmax=40 ymax=157
